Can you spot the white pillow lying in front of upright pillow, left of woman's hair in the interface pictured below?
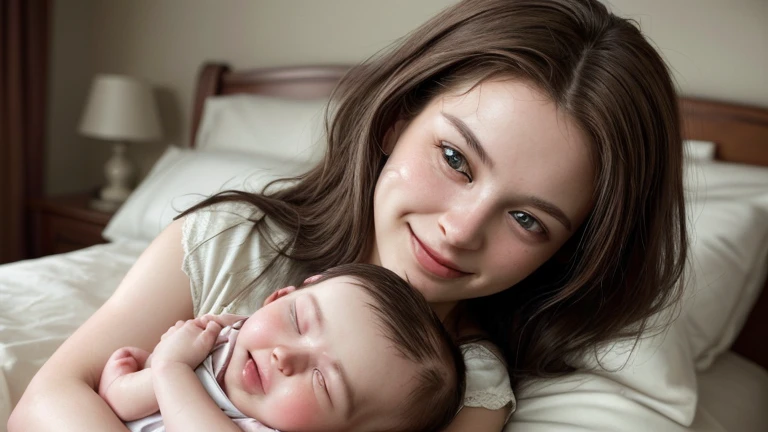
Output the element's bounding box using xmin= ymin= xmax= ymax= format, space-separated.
xmin=103 ymin=147 xmax=310 ymax=242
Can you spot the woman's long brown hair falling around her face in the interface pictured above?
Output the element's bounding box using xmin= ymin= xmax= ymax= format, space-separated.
xmin=180 ymin=0 xmax=687 ymax=386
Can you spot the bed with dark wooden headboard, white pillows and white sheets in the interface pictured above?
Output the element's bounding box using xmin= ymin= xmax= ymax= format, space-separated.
xmin=0 ymin=64 xmax=768 ymax=432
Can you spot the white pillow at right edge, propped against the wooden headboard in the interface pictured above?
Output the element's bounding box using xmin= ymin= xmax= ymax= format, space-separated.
xmin=684 ymin=162 xmax=768 ymax=371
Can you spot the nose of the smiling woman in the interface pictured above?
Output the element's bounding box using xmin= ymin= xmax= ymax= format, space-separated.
xmin=437 ymin=204 xmax=488 ymax=250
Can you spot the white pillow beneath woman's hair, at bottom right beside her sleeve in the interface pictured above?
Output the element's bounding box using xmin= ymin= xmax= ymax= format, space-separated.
xmin=504 ymin=314 xmax=697 ymax=432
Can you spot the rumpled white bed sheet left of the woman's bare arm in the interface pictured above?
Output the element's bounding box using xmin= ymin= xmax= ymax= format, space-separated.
xmin=0 ymin=242 xmax=147 ymax=431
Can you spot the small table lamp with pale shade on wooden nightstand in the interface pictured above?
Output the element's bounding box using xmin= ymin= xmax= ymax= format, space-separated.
xmin=78 ymin=75 xmax=162 ymax=212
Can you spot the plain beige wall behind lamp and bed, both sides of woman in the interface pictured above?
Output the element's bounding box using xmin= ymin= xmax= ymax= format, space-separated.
xmin=46 ymin=0 xmax=768 ymax=193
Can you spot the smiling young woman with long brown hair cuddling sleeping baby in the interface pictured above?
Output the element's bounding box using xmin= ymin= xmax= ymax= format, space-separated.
xmin=10 ymin=0 xmax=687 ymax=432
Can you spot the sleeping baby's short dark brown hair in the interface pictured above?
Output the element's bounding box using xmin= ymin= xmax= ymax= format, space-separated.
xmin=308 ymin=264 xmax=465 ymax=432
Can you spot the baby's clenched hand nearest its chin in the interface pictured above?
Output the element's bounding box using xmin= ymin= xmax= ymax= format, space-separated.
xmin=152 ymin=320 xmax=221 ymax=369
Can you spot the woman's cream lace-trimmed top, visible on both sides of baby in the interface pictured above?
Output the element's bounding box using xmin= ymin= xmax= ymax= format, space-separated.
xmin=182 ymin=203 xmax=516 ymax=419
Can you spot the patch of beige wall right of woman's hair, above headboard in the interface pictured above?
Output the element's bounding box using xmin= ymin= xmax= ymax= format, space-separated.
xmin=606 ymin=0 xmax=768 ymax=104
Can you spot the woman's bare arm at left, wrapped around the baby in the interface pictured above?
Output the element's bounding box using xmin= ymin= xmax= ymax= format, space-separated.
xmin=8 ymin=219 xmax=193 ymax=432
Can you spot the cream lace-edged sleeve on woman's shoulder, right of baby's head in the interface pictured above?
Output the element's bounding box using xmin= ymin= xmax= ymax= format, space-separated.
xmin=461 ymin=341 xmax=517 ymax=418
